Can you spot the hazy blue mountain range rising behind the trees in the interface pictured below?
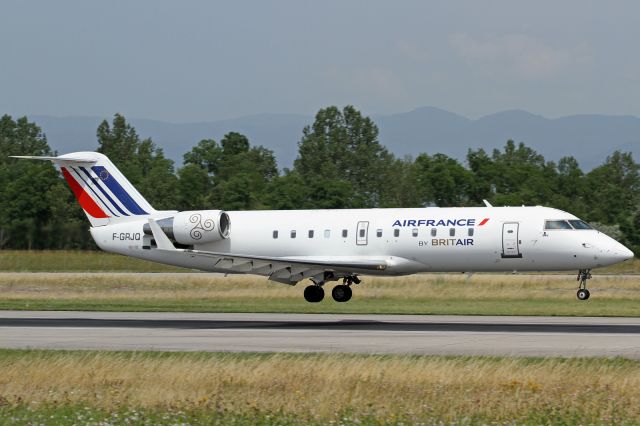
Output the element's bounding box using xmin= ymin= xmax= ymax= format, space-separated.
xmin=30 ymin=107 xmax=640 ymax=170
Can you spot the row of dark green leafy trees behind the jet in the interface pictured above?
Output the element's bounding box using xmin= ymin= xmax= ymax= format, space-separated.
xmin=0 ymin=106 xmax=640 ymax=253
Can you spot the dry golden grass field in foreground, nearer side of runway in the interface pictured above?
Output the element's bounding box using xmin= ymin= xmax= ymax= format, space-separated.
xmin=0 ymin=350 xmax=640 ymax=424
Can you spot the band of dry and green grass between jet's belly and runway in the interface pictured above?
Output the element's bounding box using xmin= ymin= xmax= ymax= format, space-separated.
xmin=0 ymin=272 xmax=640 ymax=316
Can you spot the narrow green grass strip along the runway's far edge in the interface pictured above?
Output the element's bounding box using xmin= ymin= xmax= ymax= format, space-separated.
xmin=0 ymin=296 xmax=640 ymax=317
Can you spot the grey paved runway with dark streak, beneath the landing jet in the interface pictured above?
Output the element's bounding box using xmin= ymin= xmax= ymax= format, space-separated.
xmin=0 ymin=311 xmax=640 ymax=359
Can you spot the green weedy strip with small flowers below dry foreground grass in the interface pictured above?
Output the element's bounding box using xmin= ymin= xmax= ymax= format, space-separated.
xmin=0 ymin=405 xmax=638 ymax=426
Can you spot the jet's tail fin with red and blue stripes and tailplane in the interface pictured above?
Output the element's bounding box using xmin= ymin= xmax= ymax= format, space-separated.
xmin=14 ymin=152 xmax=155 ymax=226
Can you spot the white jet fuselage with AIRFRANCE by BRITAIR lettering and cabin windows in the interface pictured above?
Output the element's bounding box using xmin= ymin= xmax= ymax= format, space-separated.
xmin=91 ymin=207 xmax=633 ymax=275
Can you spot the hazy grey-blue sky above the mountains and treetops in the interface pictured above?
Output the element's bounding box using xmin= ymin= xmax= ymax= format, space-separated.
xmin=0 ymin=0 xmax=640 ymax=122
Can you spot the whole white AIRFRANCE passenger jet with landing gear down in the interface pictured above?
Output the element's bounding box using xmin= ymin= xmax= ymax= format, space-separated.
xmin=15 ymin=152 xmax=634 ymax=303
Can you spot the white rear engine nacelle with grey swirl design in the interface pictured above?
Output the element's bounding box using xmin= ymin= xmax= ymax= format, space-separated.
xmin=143 ymin=210 xmax=231 ymax=245
